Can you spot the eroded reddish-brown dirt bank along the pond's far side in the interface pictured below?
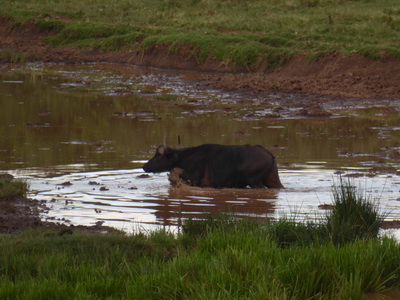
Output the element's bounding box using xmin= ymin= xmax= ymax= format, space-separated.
xmin=0 ymin=17 xmax=400 ymax=99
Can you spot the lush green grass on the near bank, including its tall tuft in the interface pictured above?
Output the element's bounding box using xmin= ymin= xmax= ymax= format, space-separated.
xmin=0 ymin=177 xmax=400 ymax=299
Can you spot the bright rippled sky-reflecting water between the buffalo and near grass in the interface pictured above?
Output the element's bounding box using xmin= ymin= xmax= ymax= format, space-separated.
xmin=9 ymin=162 xmax=400 ymax=237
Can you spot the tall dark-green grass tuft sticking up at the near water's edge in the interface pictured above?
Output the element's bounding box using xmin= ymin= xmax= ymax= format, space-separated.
xmin=326 ymin=178 xmax=383 ymax=244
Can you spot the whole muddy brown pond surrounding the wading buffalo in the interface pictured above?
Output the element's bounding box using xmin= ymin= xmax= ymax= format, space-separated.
xmin=0 ymin=64 xmax=400 ymax=231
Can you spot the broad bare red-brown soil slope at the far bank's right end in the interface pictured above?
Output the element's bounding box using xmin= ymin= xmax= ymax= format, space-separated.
xmin=205 ymin=53 xmax=400 ymax=99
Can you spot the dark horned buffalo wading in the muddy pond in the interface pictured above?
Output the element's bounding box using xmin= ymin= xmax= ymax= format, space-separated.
xmin=143 ymin=144 xmax=283 ymax=188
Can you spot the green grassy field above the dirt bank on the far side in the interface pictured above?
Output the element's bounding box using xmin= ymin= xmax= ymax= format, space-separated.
xmin=0 ymin=0 xmax=400 ymax=69
